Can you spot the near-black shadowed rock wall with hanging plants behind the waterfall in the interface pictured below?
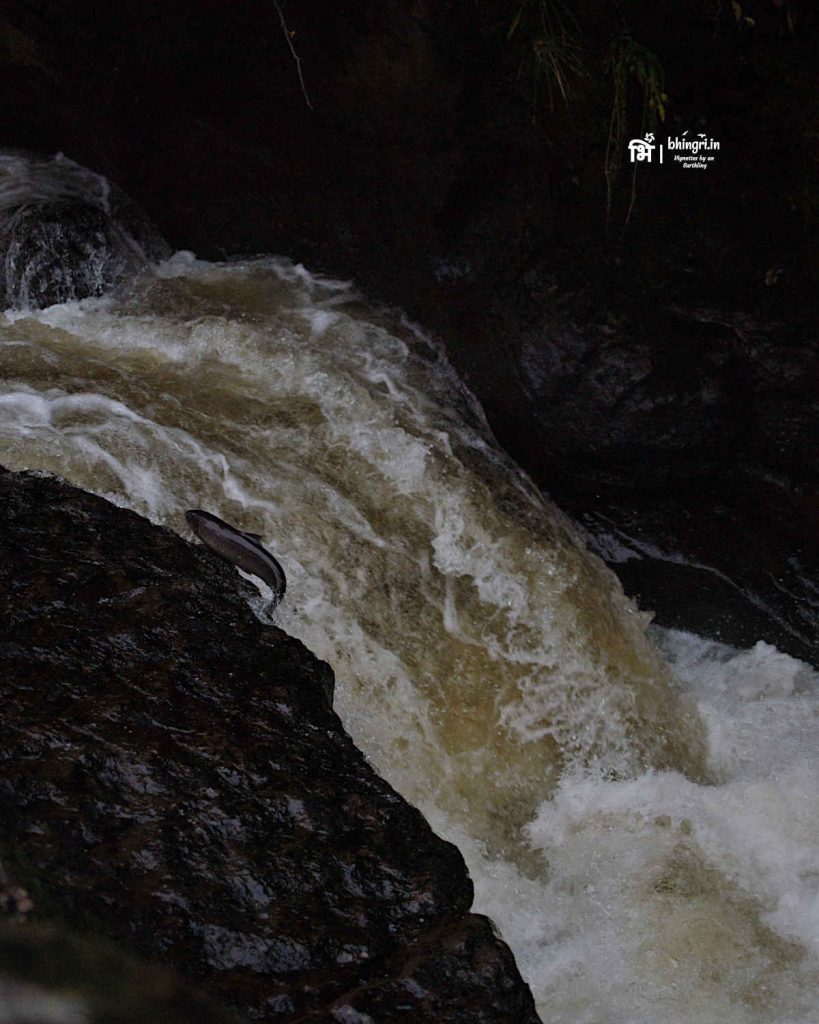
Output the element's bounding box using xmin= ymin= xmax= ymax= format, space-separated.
xmin=0 ymin=0 xmax=819 ymax=662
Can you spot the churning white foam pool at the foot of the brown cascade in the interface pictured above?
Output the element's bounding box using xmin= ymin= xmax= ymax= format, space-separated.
xmin=428 ymin=630 xmax=819 ymax=1024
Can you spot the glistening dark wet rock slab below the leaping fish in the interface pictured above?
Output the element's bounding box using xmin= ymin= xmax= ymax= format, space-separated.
xmin=0 ymin=471 xmax=537 ymax=1024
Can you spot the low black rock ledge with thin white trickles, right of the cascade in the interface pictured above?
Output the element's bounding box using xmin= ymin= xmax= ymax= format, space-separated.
xmin=575 ymin=491 xmax=819 ymax=666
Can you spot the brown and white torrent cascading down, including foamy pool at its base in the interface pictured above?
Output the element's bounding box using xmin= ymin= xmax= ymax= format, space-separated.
xmin=0 ymin=155 xmax=819 ymax=1024
